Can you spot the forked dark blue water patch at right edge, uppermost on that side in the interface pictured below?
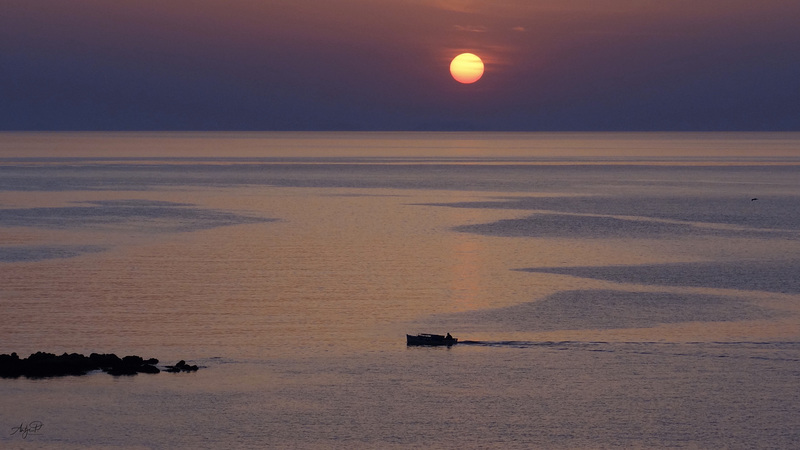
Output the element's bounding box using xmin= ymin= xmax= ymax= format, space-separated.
xmin=439 ymin=195 xmax=800 ymax=239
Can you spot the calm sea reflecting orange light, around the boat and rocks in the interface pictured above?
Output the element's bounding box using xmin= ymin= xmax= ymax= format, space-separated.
xmin=0 ymin=132 xmax=800 ymax=449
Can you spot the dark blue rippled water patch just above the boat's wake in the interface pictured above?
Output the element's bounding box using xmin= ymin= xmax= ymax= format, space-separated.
xmin=433 ymin=290 xmax=786 ymax=332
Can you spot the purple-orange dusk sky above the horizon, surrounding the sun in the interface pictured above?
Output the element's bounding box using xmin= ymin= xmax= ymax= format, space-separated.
xmin=0 ymin=0 xmax=800 ymax=131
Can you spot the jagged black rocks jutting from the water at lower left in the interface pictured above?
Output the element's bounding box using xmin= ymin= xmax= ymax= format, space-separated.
xmin=0 ymin=352 xmax=197 ymax=378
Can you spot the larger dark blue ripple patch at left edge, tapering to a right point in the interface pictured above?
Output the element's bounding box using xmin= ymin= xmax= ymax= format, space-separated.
xmin=0 ymin=200 xmax=275 ymax=232
